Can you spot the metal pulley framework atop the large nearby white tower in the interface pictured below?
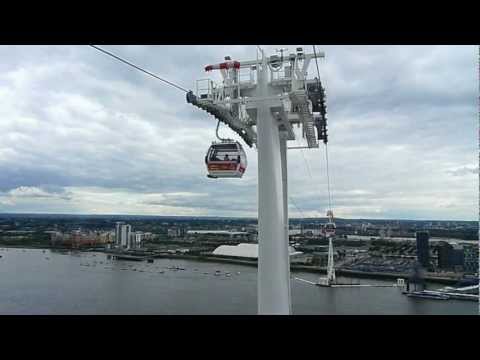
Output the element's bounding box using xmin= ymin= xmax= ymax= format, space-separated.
xmin=186 ymin=48 xmax=328 ymax=148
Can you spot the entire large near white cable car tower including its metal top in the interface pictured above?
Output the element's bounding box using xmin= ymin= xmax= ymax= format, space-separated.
xmin=187 ymin=48 xmax=327 ymax=314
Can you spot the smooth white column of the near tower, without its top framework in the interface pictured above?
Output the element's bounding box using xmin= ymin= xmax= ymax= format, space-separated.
xmin=257 ymin=57 xmax=290 ymax=315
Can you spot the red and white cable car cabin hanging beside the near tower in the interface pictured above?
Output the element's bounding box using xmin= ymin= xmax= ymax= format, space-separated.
xmin=205 ymin=141 xmax=247 ymax=179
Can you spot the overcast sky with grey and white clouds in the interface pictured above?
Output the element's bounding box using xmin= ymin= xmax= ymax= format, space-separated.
xmin=0 ymin=45 xmax=479 ymax=220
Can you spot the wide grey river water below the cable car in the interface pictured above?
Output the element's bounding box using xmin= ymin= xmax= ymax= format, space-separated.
xmin=0 ymin=248 xmax=478 ymax=315
